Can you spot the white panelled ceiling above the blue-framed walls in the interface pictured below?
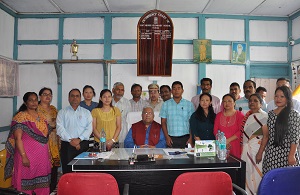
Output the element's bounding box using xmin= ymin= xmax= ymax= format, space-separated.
xmin=0 ymin=0 xmax=300 ymax=17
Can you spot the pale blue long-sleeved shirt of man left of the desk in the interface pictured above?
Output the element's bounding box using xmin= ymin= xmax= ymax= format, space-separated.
xmin=56 ymin=106 xmax=93 ymax=142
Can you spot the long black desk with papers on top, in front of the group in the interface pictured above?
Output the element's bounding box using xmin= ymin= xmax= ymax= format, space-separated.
xmin=68 ymin=148 xmax=246 ymax=195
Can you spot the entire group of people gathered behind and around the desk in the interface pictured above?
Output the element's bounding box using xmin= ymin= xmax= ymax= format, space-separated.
xmin=5 ymin=78 xmax=300 ymax=194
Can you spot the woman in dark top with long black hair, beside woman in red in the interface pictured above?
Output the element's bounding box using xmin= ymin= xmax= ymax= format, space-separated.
xmin=190 ymin=93 xmax=216 ymax=144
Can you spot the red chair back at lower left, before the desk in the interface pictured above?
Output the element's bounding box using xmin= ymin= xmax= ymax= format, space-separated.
xmin=57 ymin=173 xmax=120 ymax=195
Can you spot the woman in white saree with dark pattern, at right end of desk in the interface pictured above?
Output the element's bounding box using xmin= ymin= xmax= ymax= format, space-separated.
xmin=241 ymin=93 xmax=268 ymax=194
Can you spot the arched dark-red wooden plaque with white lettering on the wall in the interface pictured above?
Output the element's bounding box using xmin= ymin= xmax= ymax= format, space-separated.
xmin=137 ymin=10 xmax=174 ymax=76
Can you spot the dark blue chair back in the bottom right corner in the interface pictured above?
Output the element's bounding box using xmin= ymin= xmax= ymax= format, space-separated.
xmin=257 ymin=167 xmax=300 ymax=195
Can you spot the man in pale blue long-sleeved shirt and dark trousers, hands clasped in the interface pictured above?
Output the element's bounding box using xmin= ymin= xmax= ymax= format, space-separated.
xmin=56 ymin=89 xmax=93 ymax=174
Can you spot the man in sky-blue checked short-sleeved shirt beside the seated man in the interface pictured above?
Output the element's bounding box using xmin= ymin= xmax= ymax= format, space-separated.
xmin=159 ymin=81 xmax=195 ymax=148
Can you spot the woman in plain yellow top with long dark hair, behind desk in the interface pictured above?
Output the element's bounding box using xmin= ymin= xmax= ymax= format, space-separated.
xmin=92 ymin=89 xmax=121 ymax=150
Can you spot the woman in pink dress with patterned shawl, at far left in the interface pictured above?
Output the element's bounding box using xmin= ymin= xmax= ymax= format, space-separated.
xmin=4 ymin=92 xmax=51 ymax=195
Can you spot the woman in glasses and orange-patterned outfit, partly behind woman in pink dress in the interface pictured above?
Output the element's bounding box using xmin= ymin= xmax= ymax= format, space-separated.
xmin=37 ymin=87 xmax=60 ymax=193
